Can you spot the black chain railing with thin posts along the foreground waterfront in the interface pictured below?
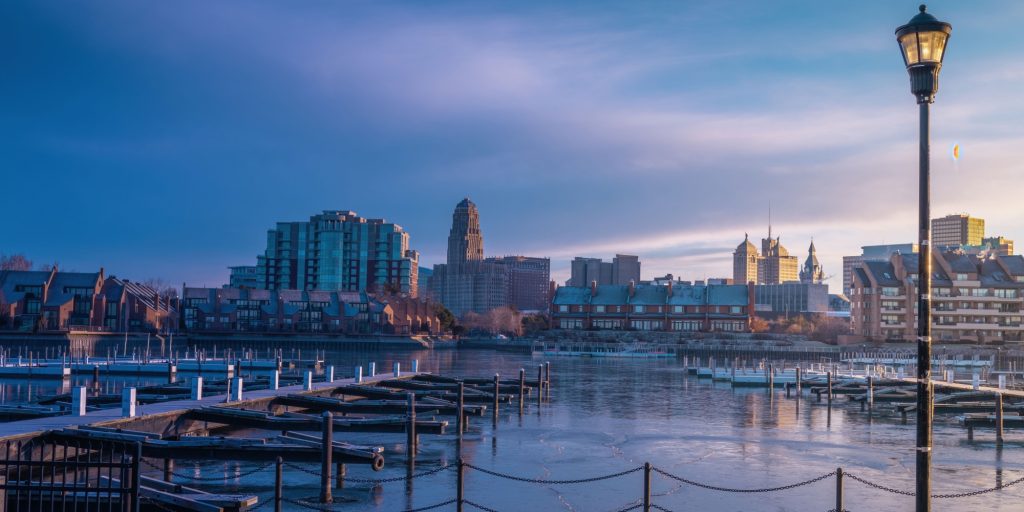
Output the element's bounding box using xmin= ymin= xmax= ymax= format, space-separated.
xmin=146 ymin=458 xmax=1024 ymax=512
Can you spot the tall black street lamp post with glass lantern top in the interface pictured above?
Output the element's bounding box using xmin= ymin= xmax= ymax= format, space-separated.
xmin=896 ymin=5 xmax=952 ymax=512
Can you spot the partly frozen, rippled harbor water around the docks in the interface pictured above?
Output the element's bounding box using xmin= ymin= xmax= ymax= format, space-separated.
xmin=4 ymin=350 xmax=1024 ymax=512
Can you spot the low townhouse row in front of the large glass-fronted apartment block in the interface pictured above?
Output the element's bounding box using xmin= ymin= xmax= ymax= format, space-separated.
xmin=181 ymin=287 xmax=440 ymax=335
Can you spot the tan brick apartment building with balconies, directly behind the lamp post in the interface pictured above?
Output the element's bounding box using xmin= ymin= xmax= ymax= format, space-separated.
xmin=850 ymin=251 xmax=1024 ymax=343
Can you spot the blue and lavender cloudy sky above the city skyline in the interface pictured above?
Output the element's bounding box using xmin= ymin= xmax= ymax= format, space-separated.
xmin=0 ymin=0 xmax=1024 ymax=292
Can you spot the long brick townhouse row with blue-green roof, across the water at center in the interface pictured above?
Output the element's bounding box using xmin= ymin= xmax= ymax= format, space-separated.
xmin=551 ymin=282 xmax=754 ymax=332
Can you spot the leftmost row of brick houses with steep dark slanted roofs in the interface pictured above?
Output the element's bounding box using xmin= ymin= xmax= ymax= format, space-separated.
xmin=0 ymin=266 xmax=177 ymax=332
